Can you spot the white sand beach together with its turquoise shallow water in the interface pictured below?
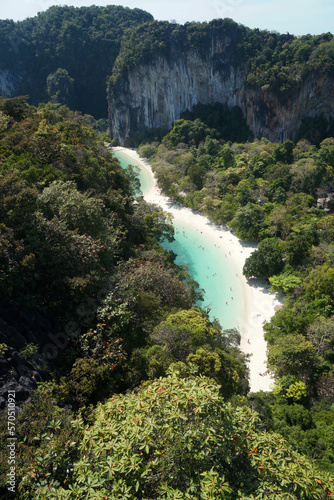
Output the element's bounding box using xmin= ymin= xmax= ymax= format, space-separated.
xmin=112 ymin=147 xmax=282 ymax=392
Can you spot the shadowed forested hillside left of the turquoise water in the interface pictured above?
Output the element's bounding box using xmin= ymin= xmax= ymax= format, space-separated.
xmin=0 ymin=97 xmax=258 ymax=498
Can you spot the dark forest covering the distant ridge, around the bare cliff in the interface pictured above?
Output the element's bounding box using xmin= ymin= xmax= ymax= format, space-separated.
xmin=0 ymin=5 xmax=334 ymax=127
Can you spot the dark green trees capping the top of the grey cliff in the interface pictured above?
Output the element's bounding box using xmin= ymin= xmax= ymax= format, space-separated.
xmin=110 ymin=14 xmax=334 ymax=98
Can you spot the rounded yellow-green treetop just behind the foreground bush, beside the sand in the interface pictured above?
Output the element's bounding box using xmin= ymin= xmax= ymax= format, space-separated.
xmin=146 ymin=309 xmax=248 ymax=397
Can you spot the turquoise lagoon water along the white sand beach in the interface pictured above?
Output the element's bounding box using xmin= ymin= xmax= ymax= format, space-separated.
xmin=113 ymin=151 xmax=245 ymax=329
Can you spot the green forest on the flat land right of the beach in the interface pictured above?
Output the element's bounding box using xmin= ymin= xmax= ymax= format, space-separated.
xmin=139 ymin=113 xmax=334 ymax=472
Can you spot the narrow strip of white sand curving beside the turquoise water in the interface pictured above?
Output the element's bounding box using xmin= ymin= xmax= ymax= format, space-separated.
xmin=113 ymin=147 xmax=282 ymax=392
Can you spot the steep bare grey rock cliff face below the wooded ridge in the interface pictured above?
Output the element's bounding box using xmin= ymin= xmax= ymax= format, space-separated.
xmin=109 ymin=37 xmax=334 ymax=144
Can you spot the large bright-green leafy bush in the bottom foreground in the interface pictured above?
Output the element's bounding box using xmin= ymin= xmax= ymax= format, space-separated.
xmin=39 ymin=375 xmax=332 ymax=500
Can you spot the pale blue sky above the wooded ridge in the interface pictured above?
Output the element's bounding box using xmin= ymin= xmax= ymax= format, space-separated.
xmin=0 ymin=0 xmax=334 ymax=36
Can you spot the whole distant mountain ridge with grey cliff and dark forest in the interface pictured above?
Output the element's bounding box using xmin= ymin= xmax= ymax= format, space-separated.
xmin=0 ymin=6 xmax=334 ymax=145
